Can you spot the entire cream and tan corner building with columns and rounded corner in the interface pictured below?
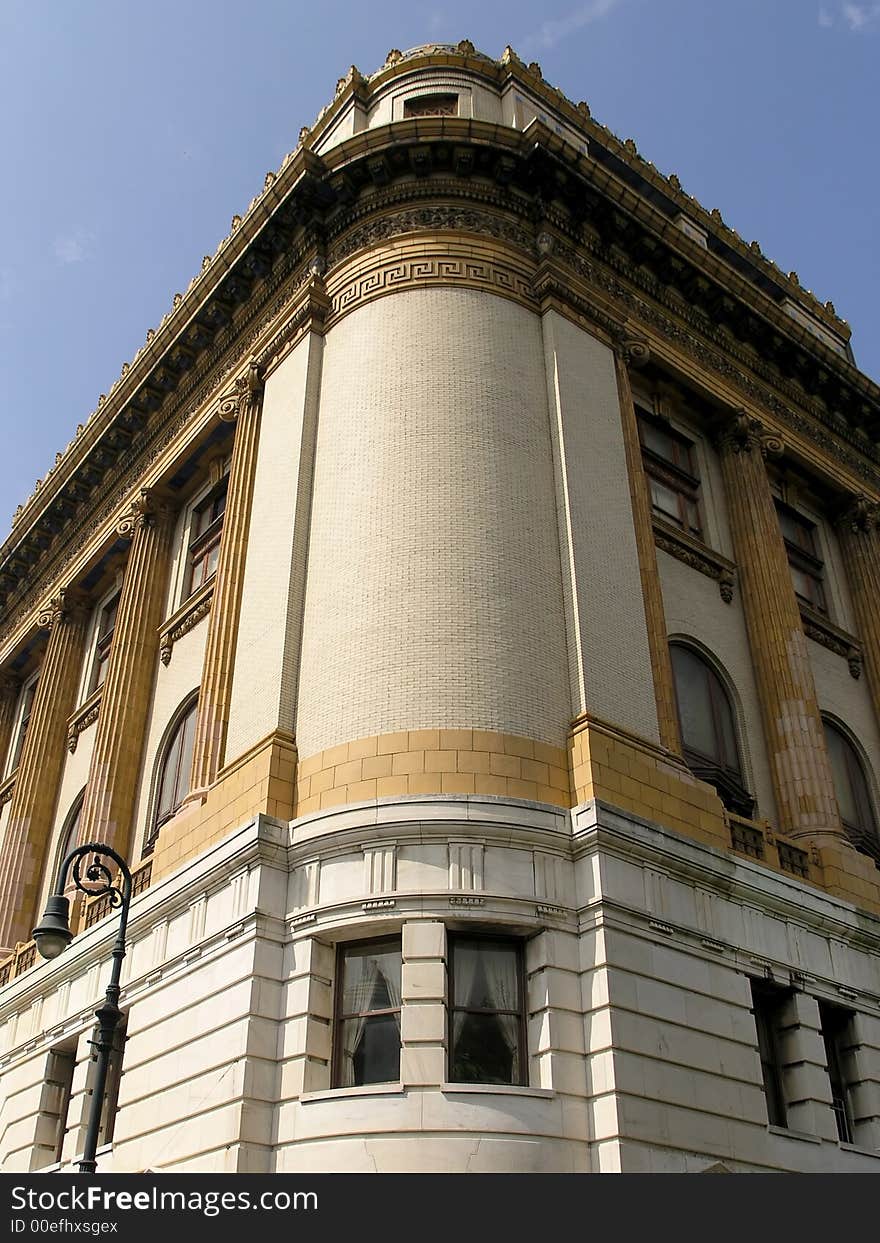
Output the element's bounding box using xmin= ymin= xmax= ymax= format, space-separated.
xmin=0 ymin=42 xmax=880 ymax=1172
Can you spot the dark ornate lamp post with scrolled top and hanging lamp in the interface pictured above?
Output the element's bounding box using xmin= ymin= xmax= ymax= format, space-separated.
xmin=34 ymin=842 xmax=132 ymax=1173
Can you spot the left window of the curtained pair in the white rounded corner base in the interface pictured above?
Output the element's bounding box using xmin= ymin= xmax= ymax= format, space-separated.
xmin=333 ymin=937 xmax=401 ymax=1088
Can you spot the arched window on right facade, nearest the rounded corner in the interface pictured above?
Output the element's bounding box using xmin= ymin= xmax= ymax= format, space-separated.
xmin=670 ymin=643 xmax=754 ymax=817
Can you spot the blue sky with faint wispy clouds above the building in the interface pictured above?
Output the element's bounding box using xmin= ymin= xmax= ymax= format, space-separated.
xmin=0 ymin=0 xmax=880 ymax=541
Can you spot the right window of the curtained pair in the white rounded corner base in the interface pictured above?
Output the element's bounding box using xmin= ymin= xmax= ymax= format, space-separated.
xmin=449 ymin=936 xmax=528 ymax=1084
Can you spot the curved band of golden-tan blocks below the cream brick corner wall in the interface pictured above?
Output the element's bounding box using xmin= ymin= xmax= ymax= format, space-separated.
xmin=296 ymin=728 xmax=572 ymax=815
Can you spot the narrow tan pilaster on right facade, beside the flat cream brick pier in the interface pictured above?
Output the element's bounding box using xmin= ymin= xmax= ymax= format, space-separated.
xmin=614 ymin=341 xmax=681 ymax=756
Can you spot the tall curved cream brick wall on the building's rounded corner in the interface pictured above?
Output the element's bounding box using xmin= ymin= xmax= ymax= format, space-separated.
xmin=296 ymin=288 xmax=571 ymax=755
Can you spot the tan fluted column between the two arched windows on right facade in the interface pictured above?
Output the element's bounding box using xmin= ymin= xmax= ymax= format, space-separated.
xmin=718 ymin=411 xmax=843 ymax=839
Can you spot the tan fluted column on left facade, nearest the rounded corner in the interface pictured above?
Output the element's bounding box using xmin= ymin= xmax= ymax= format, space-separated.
xmin=191 ymin=364 xmax=262 ymax=791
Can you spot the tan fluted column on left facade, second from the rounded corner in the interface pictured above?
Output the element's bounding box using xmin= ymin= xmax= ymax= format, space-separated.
xmin=80 ymin=490 xmax=174 ymax=854
